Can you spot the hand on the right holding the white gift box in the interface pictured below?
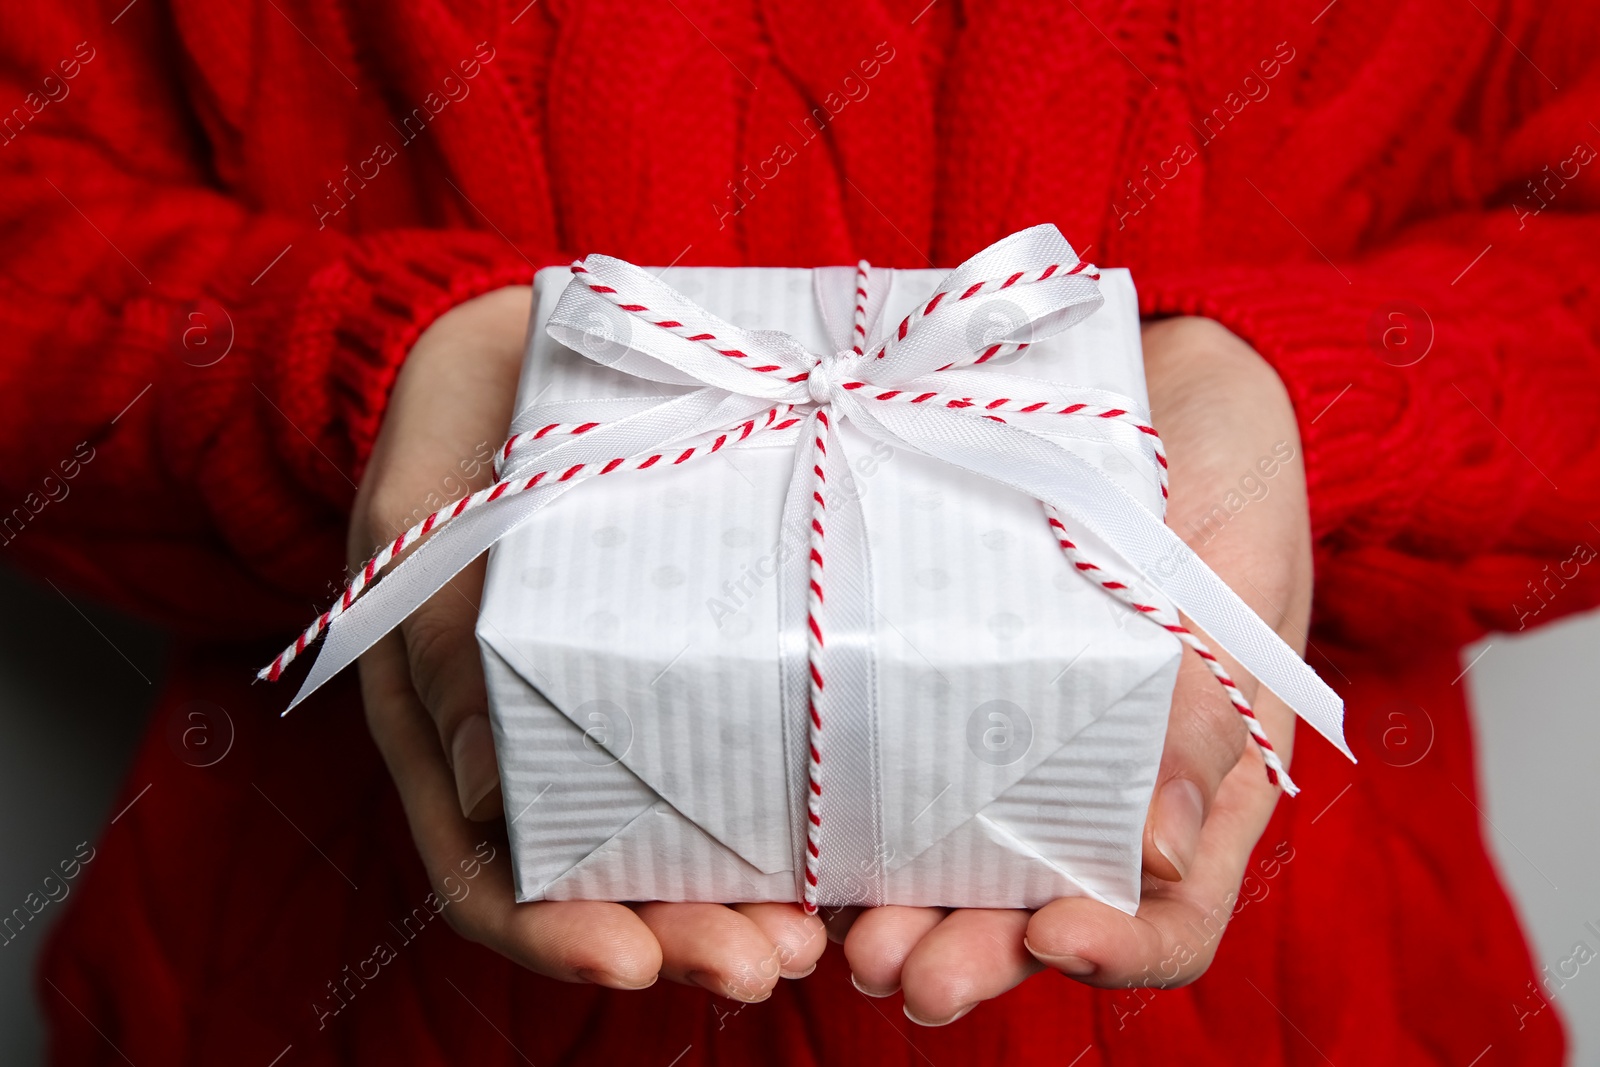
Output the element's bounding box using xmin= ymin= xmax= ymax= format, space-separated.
xmin=830 ymin=318 xmax=1312 ymax=1025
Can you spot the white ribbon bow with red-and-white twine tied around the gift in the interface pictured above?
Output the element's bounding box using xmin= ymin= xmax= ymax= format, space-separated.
xmin=261 ymin=226 xmax=1354 ymax=909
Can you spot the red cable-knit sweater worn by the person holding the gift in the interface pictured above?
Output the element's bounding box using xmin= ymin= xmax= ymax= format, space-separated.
xmin=0 ymin=0 xmax=1600 ymax=1067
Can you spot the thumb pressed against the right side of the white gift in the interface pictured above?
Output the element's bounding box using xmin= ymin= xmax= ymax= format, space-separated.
xmin=1144 ymin=648 xmax=1266 ymax=881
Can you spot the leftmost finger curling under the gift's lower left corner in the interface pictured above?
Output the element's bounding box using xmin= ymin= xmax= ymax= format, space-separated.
xmin=360 ymin=633 xmax=661 ymax=989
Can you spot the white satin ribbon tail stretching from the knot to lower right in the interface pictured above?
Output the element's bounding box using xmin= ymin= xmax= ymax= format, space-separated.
xmin=846 ymin=402 xmax=1355 ymax=763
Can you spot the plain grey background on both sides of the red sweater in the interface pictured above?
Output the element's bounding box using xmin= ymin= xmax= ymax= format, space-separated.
xmin=0 ymin=569 xmax=1600 ymax=1065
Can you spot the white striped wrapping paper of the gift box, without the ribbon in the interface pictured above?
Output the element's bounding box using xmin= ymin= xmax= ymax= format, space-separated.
xmin=477 ymin=255 xmax=1181 ymax=912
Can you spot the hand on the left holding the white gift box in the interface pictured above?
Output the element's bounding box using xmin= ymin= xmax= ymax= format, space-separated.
xmin=349 ymin=288 xmax=827 ymax=1001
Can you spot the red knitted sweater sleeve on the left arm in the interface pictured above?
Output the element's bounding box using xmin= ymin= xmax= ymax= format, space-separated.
xmin=0 ymin=16 xmax=555 ymax=635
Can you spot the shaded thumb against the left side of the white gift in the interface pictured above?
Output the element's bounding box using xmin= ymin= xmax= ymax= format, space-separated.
xmin=400 ymin=558 xmax=501 ymax=821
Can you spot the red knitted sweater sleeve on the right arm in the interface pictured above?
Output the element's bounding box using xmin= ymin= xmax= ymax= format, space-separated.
xmin=1141 ymin=0 xmax=1600 ymax=661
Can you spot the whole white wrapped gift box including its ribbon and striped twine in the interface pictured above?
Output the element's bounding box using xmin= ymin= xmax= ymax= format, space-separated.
xmin=262 ymin=226 xmax=1349 ymax=912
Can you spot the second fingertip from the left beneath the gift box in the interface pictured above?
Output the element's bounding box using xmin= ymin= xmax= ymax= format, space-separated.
xmin=634 ymin=902 xmax=790 ymax=1003
